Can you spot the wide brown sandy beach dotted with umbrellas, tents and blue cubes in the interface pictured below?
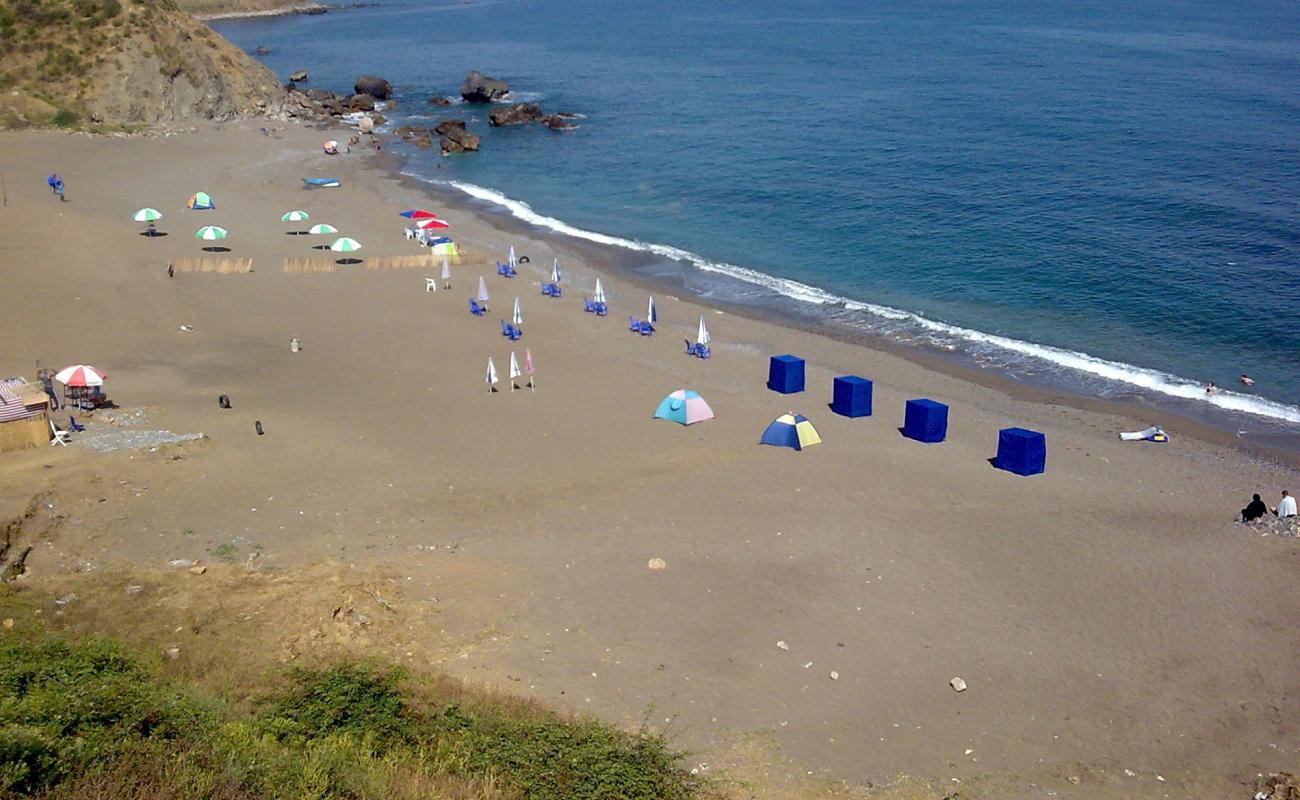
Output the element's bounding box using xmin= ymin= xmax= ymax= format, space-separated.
xmin=0 ymin=122 xmax=1300 ymax=797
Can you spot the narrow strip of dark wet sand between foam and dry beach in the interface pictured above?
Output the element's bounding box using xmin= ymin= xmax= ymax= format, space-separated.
xmin=377 ymin=153 xmax=1300 ymax=468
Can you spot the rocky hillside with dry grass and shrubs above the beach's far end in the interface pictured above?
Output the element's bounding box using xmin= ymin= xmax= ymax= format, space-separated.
xmin=0 ymin=0 xmax=282 ymax=127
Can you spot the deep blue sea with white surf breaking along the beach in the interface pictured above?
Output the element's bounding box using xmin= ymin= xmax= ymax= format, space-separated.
xmin=213 ymin=0 xmax=1300 ymax=449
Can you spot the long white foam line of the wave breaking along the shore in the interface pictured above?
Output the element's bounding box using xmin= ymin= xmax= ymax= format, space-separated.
xmin=431 ymin=176 xmax=1300 ymax=424
